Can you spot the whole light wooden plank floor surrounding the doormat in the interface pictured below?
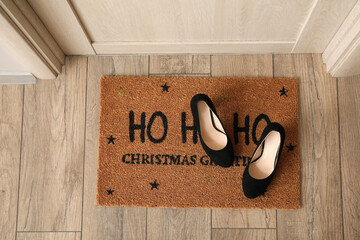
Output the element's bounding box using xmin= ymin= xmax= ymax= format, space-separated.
xmin=0 ymin=54 xmax=360 ymax=240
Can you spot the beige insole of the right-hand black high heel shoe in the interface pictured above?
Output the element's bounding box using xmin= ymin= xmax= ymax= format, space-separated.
xmin=249 ymin=131 xmax=281 ymax=179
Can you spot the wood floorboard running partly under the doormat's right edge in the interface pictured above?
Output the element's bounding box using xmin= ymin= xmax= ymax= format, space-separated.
xmin=274 ymin=54 xmax=342 ymax=239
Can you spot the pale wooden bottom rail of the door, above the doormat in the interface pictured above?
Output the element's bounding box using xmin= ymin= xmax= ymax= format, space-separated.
xmin=92 ymin=41 xmax=295 ymax=55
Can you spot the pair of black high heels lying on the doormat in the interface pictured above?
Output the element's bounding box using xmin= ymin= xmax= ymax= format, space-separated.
xmin=190 ymin=94 xmax=285 ymax=198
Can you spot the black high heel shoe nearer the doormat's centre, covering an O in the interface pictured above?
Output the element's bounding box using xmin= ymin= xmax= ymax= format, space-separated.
xmin=190 ymin=94 xmax=234 ymax=167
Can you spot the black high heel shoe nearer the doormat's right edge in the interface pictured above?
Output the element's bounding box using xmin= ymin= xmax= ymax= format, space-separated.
xmin=242 ymin=123 xmax=285 ymax=198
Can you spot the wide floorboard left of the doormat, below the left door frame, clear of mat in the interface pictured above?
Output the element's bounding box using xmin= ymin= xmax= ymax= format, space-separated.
xmin=17 ymin=57 xmax=87 ymax=231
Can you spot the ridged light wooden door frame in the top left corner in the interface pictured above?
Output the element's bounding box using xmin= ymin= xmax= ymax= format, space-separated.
xmin=0 ymin=0 xmax=65 ymax=79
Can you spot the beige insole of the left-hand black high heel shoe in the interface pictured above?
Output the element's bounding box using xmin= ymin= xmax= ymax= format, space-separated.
xmin=197 ymin=101 xmax=227 ymax=151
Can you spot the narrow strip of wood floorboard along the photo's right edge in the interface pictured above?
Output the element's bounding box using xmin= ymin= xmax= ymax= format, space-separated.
xmin=338 ymin=75 xmax=360 ymax=239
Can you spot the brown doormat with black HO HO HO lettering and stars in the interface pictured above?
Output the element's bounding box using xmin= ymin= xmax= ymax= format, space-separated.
xmin=97 ymin=76 xmax=300 ymax=209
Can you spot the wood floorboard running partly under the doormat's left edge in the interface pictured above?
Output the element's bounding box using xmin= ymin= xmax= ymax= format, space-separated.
xmin=82 ymin=56 xmax=148 ymax=240
